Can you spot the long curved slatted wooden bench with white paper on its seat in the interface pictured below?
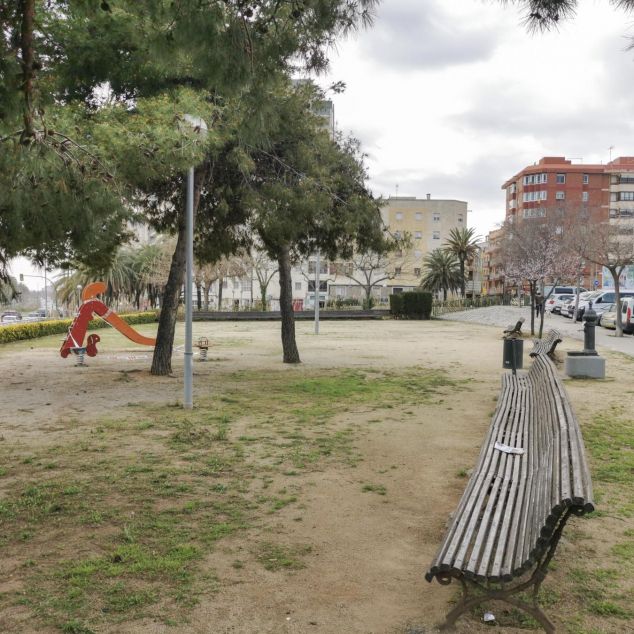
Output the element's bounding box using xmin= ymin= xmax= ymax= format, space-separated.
xmin=425 ymin=354 xmax=594 ymax=633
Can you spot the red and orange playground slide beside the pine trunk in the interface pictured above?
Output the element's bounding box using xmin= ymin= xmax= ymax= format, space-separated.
xmin=59 ymin=282 xmax=156 ymax=365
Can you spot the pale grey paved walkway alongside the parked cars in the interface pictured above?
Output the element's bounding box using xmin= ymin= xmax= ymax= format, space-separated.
xmin=441 ymin=306 xmax=634 ymax=357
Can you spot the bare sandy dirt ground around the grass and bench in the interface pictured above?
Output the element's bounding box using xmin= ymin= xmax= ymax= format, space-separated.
xmin=0 ymin=321 xmax=634 ymax=634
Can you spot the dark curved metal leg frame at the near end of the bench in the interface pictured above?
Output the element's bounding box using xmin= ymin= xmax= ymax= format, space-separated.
xmin=439 ymin=511 xmax=570 ymax=634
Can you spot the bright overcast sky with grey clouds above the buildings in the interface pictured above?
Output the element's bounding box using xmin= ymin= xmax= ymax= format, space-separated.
xmin=320 ymin=0 xmax=634 ymax=235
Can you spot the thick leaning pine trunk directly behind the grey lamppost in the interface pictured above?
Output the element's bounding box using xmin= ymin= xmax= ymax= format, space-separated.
xmin=150 ymin=167 xmax=207 ymax=376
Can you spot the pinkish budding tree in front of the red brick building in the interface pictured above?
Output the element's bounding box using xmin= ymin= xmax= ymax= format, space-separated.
xmin=501 ymin=215 xmax=579 ymax=337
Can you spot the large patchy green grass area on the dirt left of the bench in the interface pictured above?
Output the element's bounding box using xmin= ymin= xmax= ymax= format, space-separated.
xmin=0 ymin=368 xmax=455 ymax=633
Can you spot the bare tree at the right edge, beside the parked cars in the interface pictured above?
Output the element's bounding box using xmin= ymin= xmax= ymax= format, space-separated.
xmin=570 ymin=219 xmax=634 ymax=337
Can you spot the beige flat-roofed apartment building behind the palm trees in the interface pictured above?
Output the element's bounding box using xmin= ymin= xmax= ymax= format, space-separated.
xmin=381 ymin=194 xmax=467 ymax=293
